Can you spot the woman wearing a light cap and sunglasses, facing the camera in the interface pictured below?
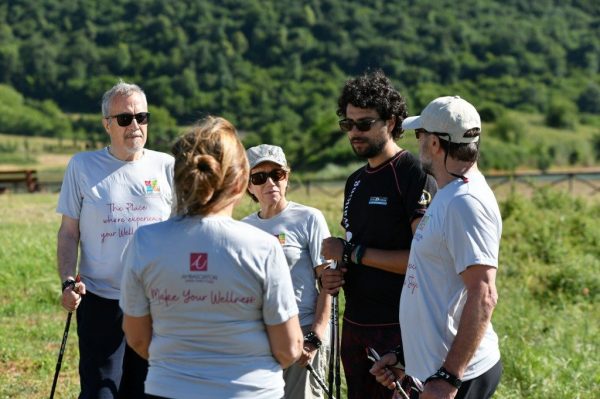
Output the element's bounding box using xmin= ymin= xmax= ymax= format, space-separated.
xmin=243 ymin=144 xmax=331 ymax=399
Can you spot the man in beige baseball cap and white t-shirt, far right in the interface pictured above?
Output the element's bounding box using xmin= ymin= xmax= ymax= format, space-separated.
xmin=371 ymin=96 xmax=502 ymax=399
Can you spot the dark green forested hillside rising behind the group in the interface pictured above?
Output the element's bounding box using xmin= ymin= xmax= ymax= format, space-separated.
xmin=0 ymin=0 xmax=600 ymax=169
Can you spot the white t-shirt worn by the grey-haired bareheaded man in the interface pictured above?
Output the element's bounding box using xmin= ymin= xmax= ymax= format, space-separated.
xmin=56 ymin=148 xmax=174 ymax=299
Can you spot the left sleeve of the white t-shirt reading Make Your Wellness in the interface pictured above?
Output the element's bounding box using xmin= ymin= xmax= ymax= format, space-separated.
xmin=119 ymin=230 xmax=150 ymax=317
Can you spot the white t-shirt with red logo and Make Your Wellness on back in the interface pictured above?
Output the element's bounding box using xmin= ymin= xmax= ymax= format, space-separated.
xmin=120 ymin=216 xmax=298 ymax=399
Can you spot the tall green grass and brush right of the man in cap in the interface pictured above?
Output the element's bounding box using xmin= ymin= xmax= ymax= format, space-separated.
xmin=494 ymin=190 xmax=600 ymax=398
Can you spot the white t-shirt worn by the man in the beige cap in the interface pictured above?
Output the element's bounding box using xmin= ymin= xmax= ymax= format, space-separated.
xmin=400 ymin=173 xmax=502 ymax=381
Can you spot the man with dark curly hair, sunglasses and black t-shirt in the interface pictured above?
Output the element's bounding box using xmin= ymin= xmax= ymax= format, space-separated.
xmin=321 ymin=71 xmax=436 ymax=399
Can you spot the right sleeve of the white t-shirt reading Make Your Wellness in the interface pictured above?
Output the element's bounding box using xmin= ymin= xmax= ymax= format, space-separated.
xmin=263 ymin=245 xmax=298 ymax=325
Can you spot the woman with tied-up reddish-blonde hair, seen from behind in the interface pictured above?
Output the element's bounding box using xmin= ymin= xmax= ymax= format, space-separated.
xmin=120 ymin=117 xmax=303 ymax=399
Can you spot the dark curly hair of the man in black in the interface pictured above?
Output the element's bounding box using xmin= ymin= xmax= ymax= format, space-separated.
xmin=337 ymin=69 xmax=408 ymax=140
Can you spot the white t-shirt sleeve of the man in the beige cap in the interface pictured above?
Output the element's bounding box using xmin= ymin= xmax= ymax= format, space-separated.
xmin=444 ymin=195 xmax=500 ymax=274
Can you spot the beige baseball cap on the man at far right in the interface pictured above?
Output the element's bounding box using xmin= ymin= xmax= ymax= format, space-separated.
xmin=402 ymin=96 xmax=481 ymax=143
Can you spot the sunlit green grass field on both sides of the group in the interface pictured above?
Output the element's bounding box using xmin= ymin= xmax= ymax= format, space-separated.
xmin=0 ymin=190 xmax=600 ymax=399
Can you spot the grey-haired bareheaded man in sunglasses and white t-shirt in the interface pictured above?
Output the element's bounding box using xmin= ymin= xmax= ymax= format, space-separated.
xmin=57 ymin=82 xmax=173 ymax=399
